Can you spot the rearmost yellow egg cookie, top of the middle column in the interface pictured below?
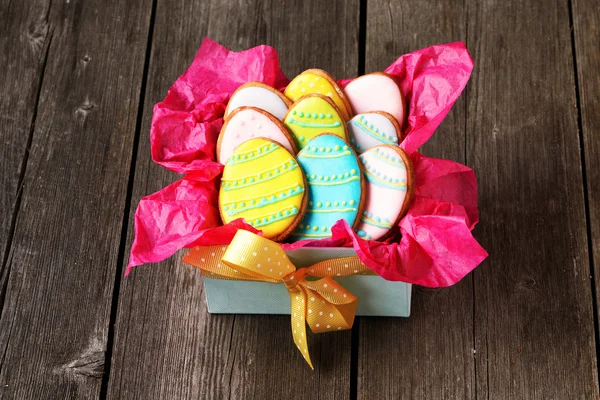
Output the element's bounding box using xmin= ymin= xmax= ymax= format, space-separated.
xmin=284 ymin=69 xmax=352 ymax=121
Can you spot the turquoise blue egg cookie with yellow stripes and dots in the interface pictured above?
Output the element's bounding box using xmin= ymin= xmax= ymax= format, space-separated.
xmin=292 ymin=134 xmax=363 ymax=240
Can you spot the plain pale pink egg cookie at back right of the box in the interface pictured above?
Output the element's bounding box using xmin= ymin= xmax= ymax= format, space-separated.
xmin=344 ymin=72 xmax=406 ymax=126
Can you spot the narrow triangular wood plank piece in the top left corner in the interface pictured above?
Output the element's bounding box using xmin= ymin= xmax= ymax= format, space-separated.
xmin=0 ymin=0 xmax=51 ymax=286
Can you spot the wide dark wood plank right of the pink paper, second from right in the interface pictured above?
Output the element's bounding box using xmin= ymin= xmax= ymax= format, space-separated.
xmin=467 ymin=0 xmax=599 ymax=399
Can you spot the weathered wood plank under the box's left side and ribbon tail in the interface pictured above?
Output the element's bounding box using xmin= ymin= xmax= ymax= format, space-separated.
xmin=108 ymin=1 xmax=359 ymax=399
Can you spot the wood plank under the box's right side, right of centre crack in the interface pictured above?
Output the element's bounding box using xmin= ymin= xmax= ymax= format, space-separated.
xmin=357 ymin=0 xmax=475 ymax=399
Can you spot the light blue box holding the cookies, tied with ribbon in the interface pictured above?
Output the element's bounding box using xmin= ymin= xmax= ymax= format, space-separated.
xmin=204 ymin=247 xmax=412 ymax=317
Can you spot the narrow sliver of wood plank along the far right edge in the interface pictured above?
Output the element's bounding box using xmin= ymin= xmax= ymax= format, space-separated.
xmin=572 ymin=0 xmax=600 ymax=346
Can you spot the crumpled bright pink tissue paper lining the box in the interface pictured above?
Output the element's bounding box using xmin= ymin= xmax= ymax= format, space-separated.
xmin=126 ymin=39 xmax=487 ymax=287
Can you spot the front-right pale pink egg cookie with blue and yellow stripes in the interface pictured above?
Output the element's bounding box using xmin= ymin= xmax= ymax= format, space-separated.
xmin=356 ymin=145 xmax=414 ymax=240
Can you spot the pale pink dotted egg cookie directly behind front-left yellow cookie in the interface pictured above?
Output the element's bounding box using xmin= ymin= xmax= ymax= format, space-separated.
xmin=217 ymin=107 xmax=297 ymax=164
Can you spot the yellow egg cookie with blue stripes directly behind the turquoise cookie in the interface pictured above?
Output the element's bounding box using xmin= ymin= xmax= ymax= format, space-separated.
xmin=283 ymin=94 xmax=348 ymax=149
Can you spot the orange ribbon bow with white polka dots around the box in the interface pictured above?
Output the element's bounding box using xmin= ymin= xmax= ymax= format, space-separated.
xmin=183 ymin=230 xmax=374 ymax=369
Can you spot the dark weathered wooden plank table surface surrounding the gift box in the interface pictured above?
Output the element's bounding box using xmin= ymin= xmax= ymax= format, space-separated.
xmin=0 ymin=0 xmax=600 ymax=399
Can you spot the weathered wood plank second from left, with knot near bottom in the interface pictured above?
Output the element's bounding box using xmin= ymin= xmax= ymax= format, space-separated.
xmin=0 ymin=0 xmax=150 ymax=399
